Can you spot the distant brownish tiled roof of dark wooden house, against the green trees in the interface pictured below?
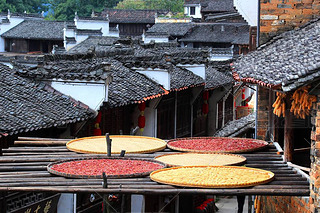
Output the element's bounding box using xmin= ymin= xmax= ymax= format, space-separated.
xmin=101 ymin=8 xmax=158 ymax=24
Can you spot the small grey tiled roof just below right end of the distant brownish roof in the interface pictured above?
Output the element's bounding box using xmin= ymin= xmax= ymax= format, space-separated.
xmin=146 ymin=23 xmax=193 ymax=36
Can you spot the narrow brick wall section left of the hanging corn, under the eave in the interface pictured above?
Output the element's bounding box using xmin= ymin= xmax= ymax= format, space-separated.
xmin=257 ymin=86 xmax=269 ymax=139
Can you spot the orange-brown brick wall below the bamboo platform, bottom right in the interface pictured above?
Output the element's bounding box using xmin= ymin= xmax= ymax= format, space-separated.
xmin=259 ymin=196 xmax=310 ymax=213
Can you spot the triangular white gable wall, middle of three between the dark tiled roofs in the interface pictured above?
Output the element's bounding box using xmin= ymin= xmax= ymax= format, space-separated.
xmin=137 ymin=68 xmax=170 ymax=90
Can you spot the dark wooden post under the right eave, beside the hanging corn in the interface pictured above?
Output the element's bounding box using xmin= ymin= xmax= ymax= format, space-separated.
xmin=284 ymin=95 xmax=294 ymax=162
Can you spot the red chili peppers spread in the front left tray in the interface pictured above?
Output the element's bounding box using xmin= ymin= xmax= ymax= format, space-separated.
xmin=51 ymin=159 xmax=163 ymax=176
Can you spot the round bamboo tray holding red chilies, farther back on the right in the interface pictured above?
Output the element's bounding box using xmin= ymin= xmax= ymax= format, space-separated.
xmin=167 ymin=137 xmax=269 ymax=153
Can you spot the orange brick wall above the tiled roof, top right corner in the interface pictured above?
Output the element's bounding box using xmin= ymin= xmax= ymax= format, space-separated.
xmin=260 ymin=0 xmax=320 ymax=44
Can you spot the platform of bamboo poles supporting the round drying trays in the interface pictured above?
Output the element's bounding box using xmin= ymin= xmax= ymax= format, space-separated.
xmin=0 ymin=138 xmax=309 ymax=196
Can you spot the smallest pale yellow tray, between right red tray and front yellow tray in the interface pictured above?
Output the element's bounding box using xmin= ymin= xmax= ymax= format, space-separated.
xmin=155 ymin=152 xmax=247 ymax=167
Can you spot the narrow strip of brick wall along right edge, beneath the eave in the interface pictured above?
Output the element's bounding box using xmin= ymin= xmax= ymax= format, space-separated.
xmin=310 ymin=95 xmax=320 ymax=212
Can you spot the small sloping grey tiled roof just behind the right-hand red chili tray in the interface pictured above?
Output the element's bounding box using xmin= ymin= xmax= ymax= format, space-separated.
xmin=213 ymin=114 xmax=255 ymax=137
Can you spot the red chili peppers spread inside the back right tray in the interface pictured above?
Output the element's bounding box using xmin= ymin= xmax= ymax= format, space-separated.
xmin=168 ymin=138 xmax=265 ymax=152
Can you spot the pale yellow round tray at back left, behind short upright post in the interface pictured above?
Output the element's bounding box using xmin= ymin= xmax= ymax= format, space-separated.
xmin=67 ymin=135 xmax=167 ymax=154
